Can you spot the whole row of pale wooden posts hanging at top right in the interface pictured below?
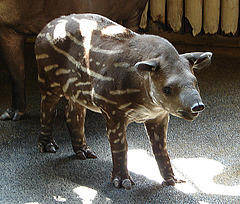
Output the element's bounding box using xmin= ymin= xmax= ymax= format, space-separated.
xmin=142 ymin=0 xmax=239 ymax=36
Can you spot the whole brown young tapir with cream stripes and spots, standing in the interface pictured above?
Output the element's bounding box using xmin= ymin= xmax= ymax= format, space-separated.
xmin=35 ymin=14 xmax=212 ymax=189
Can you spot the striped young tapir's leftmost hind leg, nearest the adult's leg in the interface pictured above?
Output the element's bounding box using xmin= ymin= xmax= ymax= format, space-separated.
xmin=38 ymin=91 xmax=60 ymax=153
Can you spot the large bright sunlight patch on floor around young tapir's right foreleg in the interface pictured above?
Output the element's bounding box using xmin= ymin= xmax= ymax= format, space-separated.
xmin=128 ymin=149 xmax=240 ymax=196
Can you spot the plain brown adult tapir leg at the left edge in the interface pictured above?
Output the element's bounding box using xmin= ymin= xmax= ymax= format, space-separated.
xmin=0 ymin=26 xmax=26 ymax=120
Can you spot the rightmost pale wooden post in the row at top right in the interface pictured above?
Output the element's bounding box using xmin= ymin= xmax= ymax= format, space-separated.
xmin=221 ymin=0 xmax=239 ymax=35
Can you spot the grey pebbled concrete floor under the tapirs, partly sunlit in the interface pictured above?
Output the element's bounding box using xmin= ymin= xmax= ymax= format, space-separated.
xmin=0 ymin=45 xmax=240 ymax=204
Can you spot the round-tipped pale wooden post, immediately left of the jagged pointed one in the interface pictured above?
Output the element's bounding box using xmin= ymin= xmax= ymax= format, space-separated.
xmin=167 ymin=0 xmax=183 ymax=32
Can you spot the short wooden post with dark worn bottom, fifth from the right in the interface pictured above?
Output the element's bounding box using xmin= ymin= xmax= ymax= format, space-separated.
xmin=150 ymin=0 xmax=166 ymax=24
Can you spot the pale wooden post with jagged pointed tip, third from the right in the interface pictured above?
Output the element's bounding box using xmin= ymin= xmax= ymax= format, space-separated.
xmin=185 ymin=0 xmax=202 ymax=36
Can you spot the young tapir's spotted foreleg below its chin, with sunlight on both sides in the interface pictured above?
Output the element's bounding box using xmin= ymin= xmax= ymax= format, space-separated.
xmin=145 ymin=112 xmax=184 ymax=185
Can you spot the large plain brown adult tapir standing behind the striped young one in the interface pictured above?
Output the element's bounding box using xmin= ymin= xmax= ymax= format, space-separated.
xmin=0 ymin=0 xmax=148 ymax=121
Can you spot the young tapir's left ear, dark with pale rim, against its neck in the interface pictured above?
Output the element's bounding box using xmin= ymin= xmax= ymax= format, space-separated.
xmin=135 ymin=59 xmax=159 ymax=75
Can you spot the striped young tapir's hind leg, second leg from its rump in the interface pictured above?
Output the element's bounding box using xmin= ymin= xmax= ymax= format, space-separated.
xmin=65 ymin=100 xmax=97 ymax=159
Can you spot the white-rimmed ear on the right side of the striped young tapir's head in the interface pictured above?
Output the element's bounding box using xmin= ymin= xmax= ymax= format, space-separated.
xmin=180 ymin=52 xmax=212 ymax=69
